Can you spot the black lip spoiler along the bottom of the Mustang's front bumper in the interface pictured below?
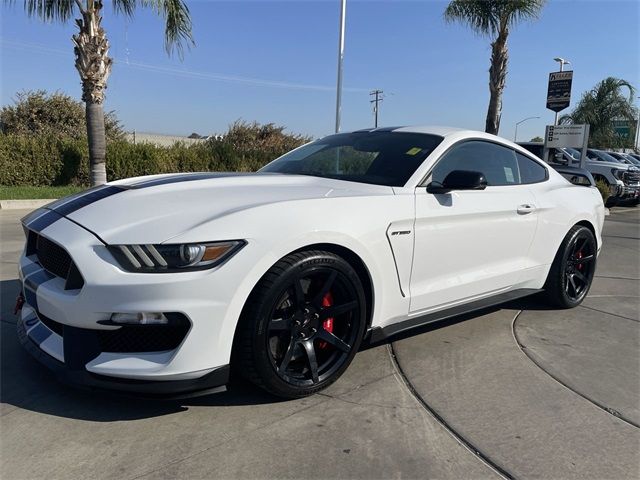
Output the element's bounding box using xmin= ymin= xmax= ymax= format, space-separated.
xmin=17 ymin=319 xmax=230 ymax=400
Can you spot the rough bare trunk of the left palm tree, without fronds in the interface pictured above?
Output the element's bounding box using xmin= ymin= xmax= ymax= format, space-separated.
xmin=73 ymin=0 xmax=112 ymax=186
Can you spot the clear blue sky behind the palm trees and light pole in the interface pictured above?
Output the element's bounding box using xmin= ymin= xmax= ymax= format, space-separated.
xmin=0 ymin=0 xmax=640 ymax=140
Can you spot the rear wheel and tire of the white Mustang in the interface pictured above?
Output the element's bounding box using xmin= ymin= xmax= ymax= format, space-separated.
xmin=544 ymin=225 xmax=597 ymax=308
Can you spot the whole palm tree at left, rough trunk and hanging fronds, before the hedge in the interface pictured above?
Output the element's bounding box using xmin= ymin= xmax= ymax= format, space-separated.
xmin=4 ymin=0 xmax=193 ymax=185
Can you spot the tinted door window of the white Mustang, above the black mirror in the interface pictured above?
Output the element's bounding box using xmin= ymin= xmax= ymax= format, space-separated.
xmin=431 ymin=141 xmax=520 ymax=186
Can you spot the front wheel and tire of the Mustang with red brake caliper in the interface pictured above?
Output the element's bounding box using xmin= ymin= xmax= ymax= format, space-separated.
xmin=233 ymin=251 xmax=366 ymax=398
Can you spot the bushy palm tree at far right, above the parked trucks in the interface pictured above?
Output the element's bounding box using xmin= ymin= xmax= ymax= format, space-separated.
xmin=560 ymin=77 xmax=638 ymax=148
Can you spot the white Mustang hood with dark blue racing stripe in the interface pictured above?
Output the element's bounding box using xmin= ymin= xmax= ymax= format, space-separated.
xmin=47 ymin=173 xmax=393 ymax=244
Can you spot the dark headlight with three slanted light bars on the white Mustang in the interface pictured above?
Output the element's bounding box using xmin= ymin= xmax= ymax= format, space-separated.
xmin=107 ymin=240 xmax=247 ymax=273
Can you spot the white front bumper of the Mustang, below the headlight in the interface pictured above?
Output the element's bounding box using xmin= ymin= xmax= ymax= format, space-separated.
xmin=18 ymin=212 xmax=246 ymax=395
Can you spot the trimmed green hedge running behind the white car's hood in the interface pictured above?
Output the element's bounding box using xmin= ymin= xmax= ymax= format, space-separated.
xmin=0 ymin=134 xmax=307 ymax=186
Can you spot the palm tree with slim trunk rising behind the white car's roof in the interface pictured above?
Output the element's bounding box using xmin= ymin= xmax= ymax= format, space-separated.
xmin=444 ymin=0 xmax=545 ymax=135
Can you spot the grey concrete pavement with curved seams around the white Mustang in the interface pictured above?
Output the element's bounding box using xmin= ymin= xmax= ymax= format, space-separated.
xmin=0 ymin=208 xmax=640 ymax=479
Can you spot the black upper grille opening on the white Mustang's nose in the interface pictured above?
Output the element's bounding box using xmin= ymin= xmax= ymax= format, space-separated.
xmin=27 ymin=231 xmax=84 ymax=290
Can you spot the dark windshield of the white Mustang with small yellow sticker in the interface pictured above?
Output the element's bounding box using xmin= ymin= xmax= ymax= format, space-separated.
xmin=260 ymin=131 xmax=442 ymax=187
